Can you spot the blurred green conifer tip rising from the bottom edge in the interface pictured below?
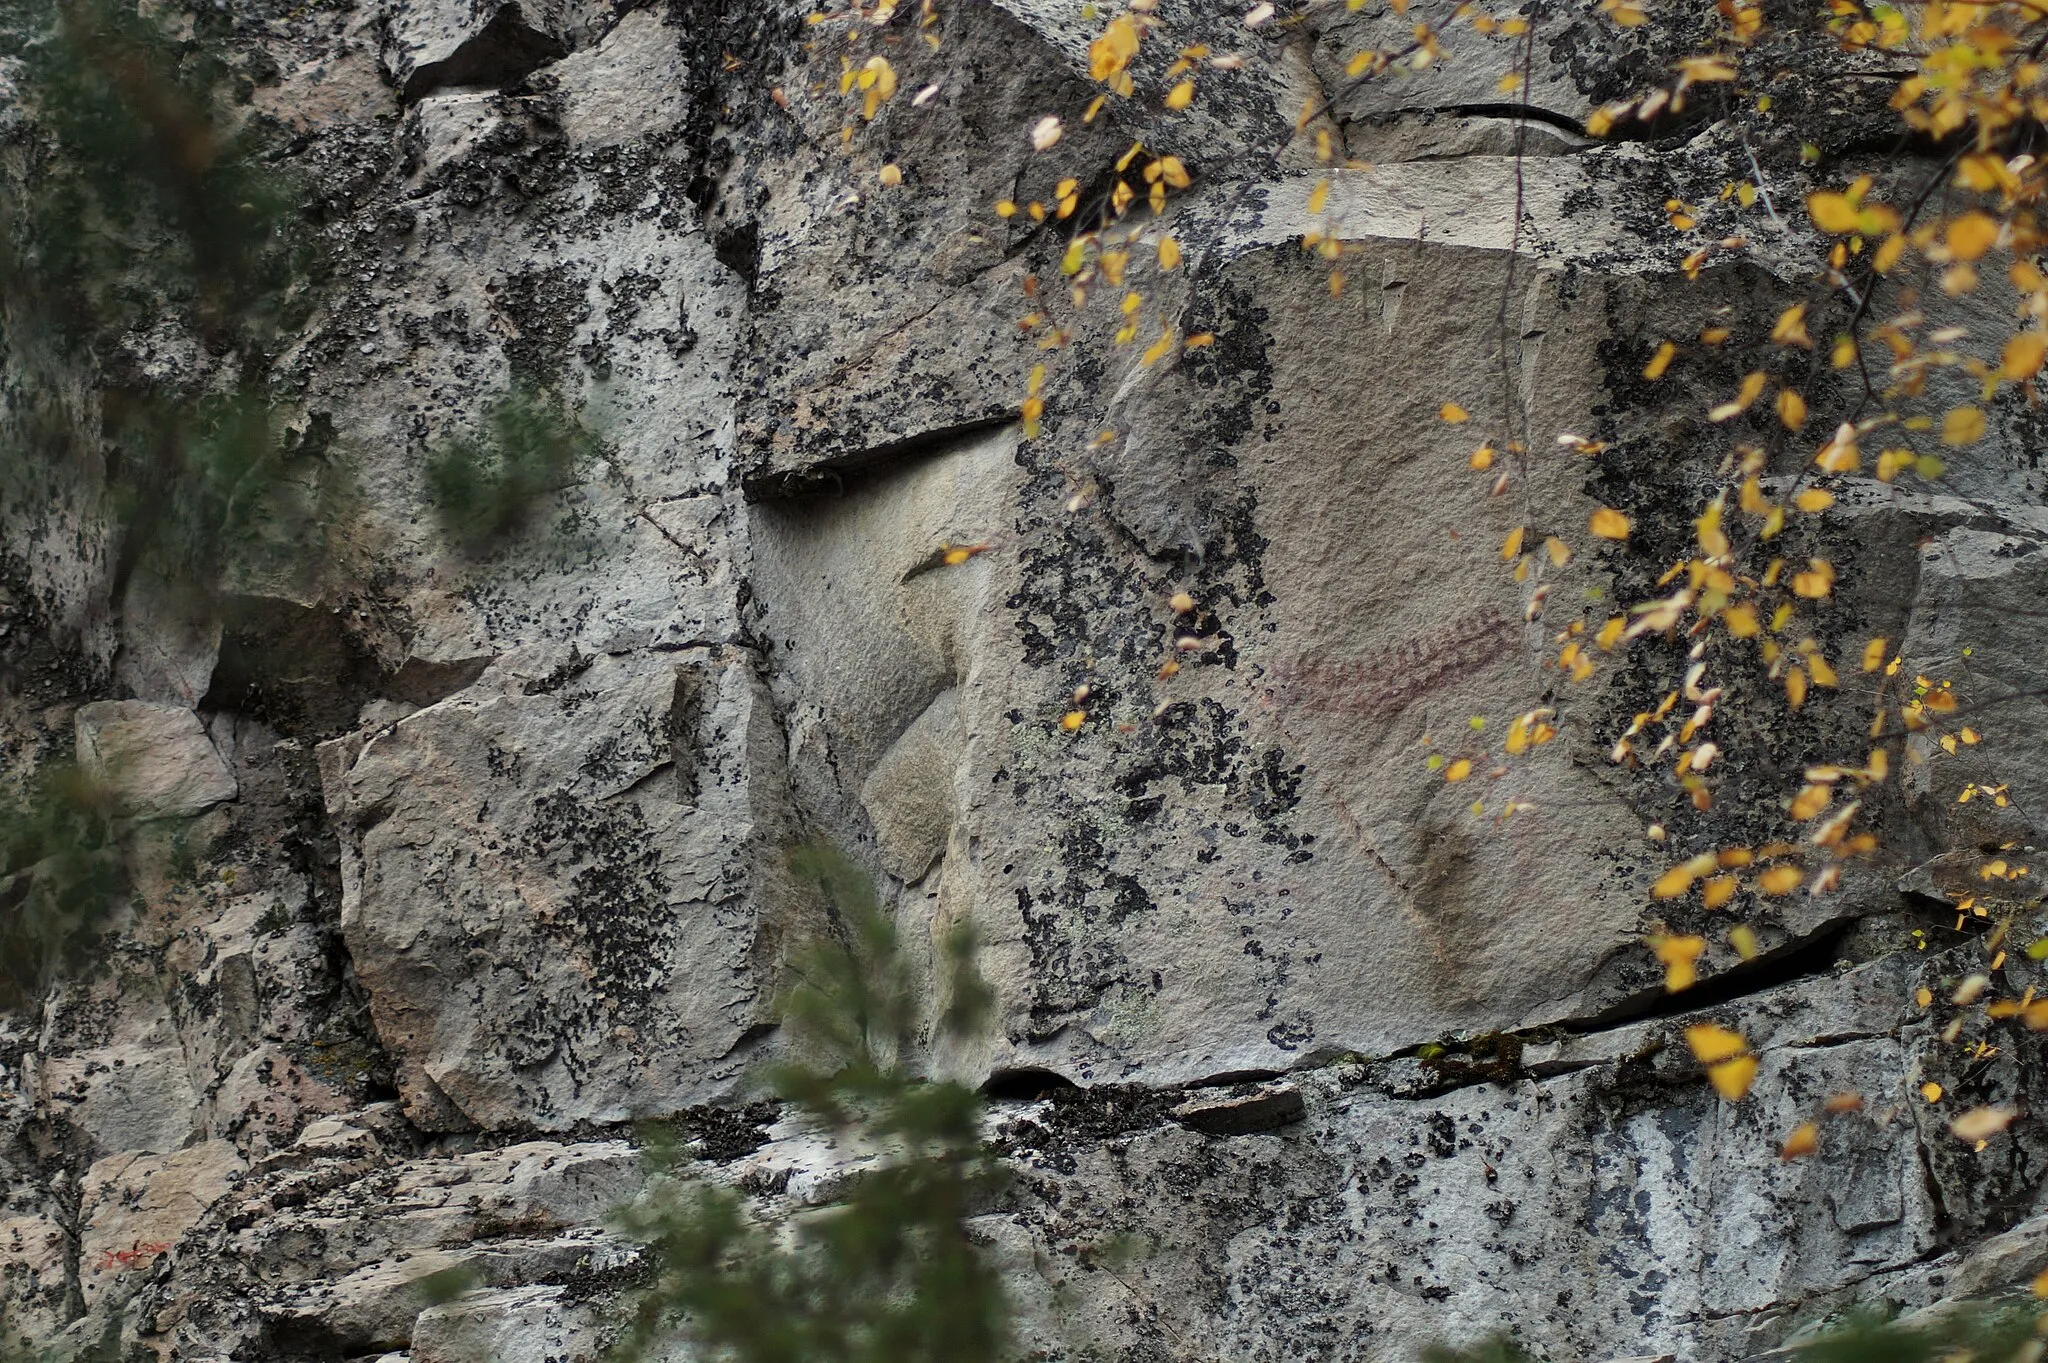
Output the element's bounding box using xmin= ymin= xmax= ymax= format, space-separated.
xmin=621 ymin=847 xmax=1008 ymax=1363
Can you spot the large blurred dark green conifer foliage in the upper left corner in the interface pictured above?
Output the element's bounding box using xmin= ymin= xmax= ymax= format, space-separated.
xmin=0 ymin=0 xmax=319 ymax=591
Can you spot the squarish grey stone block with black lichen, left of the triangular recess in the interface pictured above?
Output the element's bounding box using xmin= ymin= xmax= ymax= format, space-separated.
xmin=322 ymin=651 xmax=790 ymax=1130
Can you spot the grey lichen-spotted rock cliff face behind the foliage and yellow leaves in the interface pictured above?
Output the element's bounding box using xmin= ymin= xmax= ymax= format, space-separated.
xmin=12 ymin=0 xmax=2048 ymax=1363
